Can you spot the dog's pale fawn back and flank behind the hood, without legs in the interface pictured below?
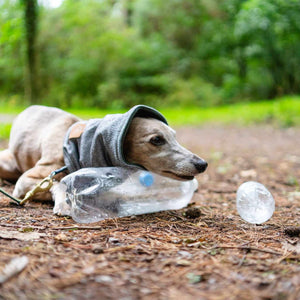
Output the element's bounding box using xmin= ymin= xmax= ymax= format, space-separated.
xmin=9 ymin=105 xmax=79 ymax=173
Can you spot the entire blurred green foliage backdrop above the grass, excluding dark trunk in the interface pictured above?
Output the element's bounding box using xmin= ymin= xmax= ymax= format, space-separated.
xmin=0 ymin=0 xmax=300 ymax=108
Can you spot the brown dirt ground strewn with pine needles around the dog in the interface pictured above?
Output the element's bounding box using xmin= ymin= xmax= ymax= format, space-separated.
xmin=0 ymin=126 xmax=300 ymax=300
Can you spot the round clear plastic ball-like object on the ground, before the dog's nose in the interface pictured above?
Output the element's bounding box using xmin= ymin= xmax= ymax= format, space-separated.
xmin=236 ymin=181 xmax=275 ymax=224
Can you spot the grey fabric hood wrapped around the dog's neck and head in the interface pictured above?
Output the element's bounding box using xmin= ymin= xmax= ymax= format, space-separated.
xmin=63 ymin=105 xmax=168 ymax=173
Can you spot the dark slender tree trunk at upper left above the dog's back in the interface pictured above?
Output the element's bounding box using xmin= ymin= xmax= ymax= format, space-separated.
xmin=22 ymin=0 xmax=38 ymax=104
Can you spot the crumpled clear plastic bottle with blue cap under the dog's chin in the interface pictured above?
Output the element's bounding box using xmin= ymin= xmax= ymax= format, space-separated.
xmin=60 ymin=167 xmax=198 ymax=223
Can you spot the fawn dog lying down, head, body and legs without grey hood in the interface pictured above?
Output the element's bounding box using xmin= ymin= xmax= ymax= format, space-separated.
xmin=0 ymin=105 xmax=207 ymax=213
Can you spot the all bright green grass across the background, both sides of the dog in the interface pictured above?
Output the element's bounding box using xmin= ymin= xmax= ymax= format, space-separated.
xmin=0 ymin=96 xmax=300 ymax=139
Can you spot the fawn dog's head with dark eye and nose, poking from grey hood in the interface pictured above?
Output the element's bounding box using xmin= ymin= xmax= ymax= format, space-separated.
xmin=124 ymin=117 xmax=207 ymax=180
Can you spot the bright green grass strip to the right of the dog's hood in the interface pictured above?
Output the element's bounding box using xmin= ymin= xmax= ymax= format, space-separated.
xmin=161 ymin=97 xmax=300 ymax=127
